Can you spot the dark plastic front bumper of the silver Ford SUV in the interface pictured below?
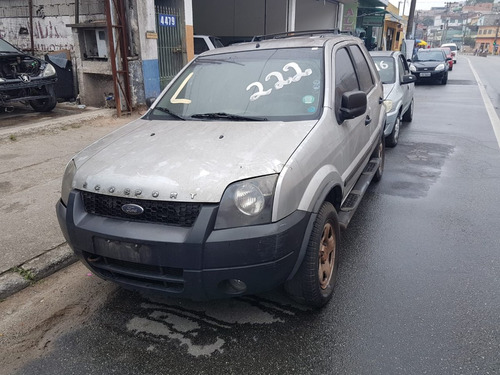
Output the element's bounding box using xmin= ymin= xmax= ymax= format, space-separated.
xmin=56 ymin=191 xmax=311 ymax=300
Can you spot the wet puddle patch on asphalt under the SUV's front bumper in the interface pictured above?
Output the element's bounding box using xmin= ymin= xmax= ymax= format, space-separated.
xmin=125 ymin=294 xmax=308 ymax=357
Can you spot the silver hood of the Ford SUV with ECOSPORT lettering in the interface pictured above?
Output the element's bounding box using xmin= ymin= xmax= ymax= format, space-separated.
xmin=73 ymin=119 xmax=316 ymax=202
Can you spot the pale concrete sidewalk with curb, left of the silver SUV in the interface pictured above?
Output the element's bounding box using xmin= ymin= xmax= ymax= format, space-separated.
xmin=0 ymin=107 xmax=140 ymax=300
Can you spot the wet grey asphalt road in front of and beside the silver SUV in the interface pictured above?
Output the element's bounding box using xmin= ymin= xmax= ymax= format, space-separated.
xmin=0 ymin=56 xmax=500 ymax=375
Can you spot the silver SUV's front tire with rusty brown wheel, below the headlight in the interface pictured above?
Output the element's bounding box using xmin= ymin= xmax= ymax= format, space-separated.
xmin=285 ymin=202 xmax=340 ymax=308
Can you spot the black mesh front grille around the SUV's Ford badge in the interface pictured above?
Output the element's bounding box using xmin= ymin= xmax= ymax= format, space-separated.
xmin=81 ymin=191 xmax=201 ymax=227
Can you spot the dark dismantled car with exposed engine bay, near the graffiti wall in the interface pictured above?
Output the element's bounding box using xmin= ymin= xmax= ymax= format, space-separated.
xmin=0 ymin=38 xmax=57 ymax=112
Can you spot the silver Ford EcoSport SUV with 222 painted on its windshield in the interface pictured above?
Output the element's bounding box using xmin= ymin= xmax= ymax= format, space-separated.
xmin=57 ymin=32 xmax=386 ymax=307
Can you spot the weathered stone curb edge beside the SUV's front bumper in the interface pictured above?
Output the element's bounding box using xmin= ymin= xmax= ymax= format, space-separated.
xmin=0 ymin=243 xmax=78 ymax=300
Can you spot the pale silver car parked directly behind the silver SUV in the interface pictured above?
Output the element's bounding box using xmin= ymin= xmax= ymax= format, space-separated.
xmin=370 ymin=51 xmax=417 ymax=147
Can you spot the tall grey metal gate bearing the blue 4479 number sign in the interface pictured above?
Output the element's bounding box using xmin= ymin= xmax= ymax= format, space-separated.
xmin=155 ymin=0 xmax=185 ymax=89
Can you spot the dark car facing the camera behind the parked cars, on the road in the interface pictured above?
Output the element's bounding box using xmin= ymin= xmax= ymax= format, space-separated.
xmin=410 ymin=48 xmax=449 ymax=85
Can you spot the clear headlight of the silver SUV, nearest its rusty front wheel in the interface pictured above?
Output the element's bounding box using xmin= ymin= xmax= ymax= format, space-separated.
xmin=215 ymin=175 xmax=278 ymax=229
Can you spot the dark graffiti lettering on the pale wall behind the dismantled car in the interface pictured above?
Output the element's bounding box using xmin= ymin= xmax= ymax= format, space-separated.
xmin=0 ymin=16 xmax=74 ymax=52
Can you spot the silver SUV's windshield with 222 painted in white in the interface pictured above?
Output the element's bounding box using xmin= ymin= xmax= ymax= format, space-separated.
xmin=150 ymin=48 xmax=323 ymax=121
